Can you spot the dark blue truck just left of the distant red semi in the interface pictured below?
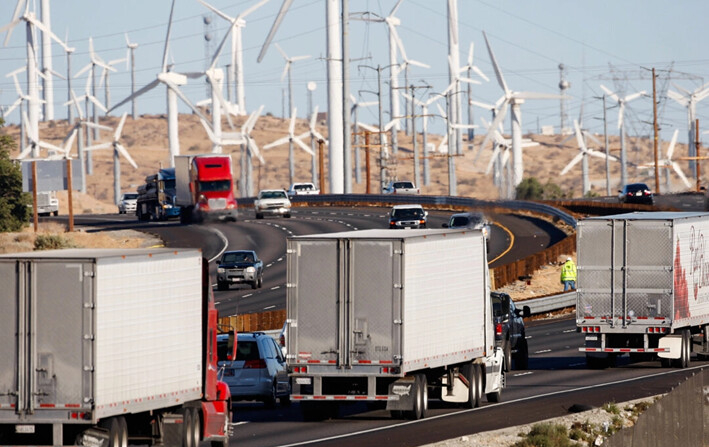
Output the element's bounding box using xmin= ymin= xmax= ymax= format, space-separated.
xmin=135 ymin=168 xmax=180 ymax=221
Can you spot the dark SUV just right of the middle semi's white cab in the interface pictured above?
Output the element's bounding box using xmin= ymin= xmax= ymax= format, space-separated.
xmin=490 ymin=292 xmax=531 ymax=371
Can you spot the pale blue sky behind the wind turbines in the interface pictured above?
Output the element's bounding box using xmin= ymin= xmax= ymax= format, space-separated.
xmin=0 ymin=0 xmax=709 ymax=150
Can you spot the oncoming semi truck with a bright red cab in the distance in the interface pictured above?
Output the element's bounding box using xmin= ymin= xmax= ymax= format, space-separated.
xmin=175 ymin=154 xmax=237 ymax=224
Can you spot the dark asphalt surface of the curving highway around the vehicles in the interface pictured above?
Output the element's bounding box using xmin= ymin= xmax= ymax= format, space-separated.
xmin=58 ymin=201 xmax=706 ymax=447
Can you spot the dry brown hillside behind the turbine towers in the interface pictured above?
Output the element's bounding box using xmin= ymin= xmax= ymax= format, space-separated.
xmin=0 ymin=114 xmax=706 ymax=213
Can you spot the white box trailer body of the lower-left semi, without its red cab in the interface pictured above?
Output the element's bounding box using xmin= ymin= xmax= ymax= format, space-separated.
xmin=0 ymin=249 xmax=203 ymax=423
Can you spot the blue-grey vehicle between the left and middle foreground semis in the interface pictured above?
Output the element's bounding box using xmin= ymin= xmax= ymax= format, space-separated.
xmin=217 ymin=332 xmax=290 ymax=407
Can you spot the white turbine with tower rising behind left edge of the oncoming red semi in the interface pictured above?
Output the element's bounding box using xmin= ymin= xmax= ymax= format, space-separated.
xmin=109 ymin=0 xmax=207 ymax=167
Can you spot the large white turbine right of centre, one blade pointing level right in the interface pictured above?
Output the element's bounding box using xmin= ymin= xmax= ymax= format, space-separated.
xmin=478 ymin=32 xmax=564 ymax=188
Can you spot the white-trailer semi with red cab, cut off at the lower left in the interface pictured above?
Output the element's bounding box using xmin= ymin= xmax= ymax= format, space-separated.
xmin=0 ymin=248 xmax=236 ymax=447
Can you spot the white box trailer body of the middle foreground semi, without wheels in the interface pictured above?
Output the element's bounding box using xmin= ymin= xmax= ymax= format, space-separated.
xmin=288 ymin=230 xmax=492 ymax=374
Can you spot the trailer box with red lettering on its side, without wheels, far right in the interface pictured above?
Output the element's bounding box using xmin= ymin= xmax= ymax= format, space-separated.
xmin=577 ymin=212 xmax=709 ymax=332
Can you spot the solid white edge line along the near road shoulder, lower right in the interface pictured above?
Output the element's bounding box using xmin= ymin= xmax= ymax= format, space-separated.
xmin=272 ymin=365 xmax=704 ymax=447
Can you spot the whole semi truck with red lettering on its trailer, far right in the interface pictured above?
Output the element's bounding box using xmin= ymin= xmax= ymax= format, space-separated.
xmin=576 ymin=212 xmax=709 ymax=368
